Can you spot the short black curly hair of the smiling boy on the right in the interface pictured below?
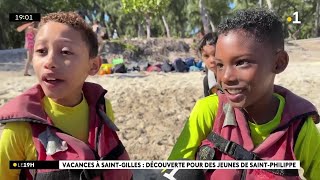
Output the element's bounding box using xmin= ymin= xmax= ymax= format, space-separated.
xmin=218 ymin=9 xmax=284 ymax=49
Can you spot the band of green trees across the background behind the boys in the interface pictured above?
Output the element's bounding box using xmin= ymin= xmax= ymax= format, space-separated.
xmin=0 ymin=0 xmax=320 ymax=49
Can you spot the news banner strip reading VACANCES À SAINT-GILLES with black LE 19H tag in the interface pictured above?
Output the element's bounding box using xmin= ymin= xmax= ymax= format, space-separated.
xmin=9 ymin=160 xmax=300 ymax=169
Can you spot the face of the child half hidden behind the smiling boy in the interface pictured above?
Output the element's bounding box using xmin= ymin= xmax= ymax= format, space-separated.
xmin=201 ymin=45 xmax=216 ymax=72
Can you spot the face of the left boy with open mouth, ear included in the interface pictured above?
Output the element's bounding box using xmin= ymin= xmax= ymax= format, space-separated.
xmin=33 ymin=22 xmax=100 ymax=106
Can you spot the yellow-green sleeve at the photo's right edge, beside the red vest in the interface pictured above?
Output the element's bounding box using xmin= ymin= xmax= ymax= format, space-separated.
xmin=294 ymin=117 xmax=320 ymax=179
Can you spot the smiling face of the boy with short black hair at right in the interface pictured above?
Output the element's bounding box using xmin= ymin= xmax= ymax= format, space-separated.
xmin=215 ymin=31 xmax=276 ymax=108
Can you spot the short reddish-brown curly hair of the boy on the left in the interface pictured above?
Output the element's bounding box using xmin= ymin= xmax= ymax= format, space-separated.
xmin=39 ymin=12 xmax=98 ymax=58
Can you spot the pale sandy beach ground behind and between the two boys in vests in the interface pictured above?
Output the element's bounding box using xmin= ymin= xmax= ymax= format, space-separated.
xmin=0 ymin=39 xmax=320 ymax=179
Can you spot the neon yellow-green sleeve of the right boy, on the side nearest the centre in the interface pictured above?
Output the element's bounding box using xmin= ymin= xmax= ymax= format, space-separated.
xmin=168 ymin=94 xmax=219 ymax=160
